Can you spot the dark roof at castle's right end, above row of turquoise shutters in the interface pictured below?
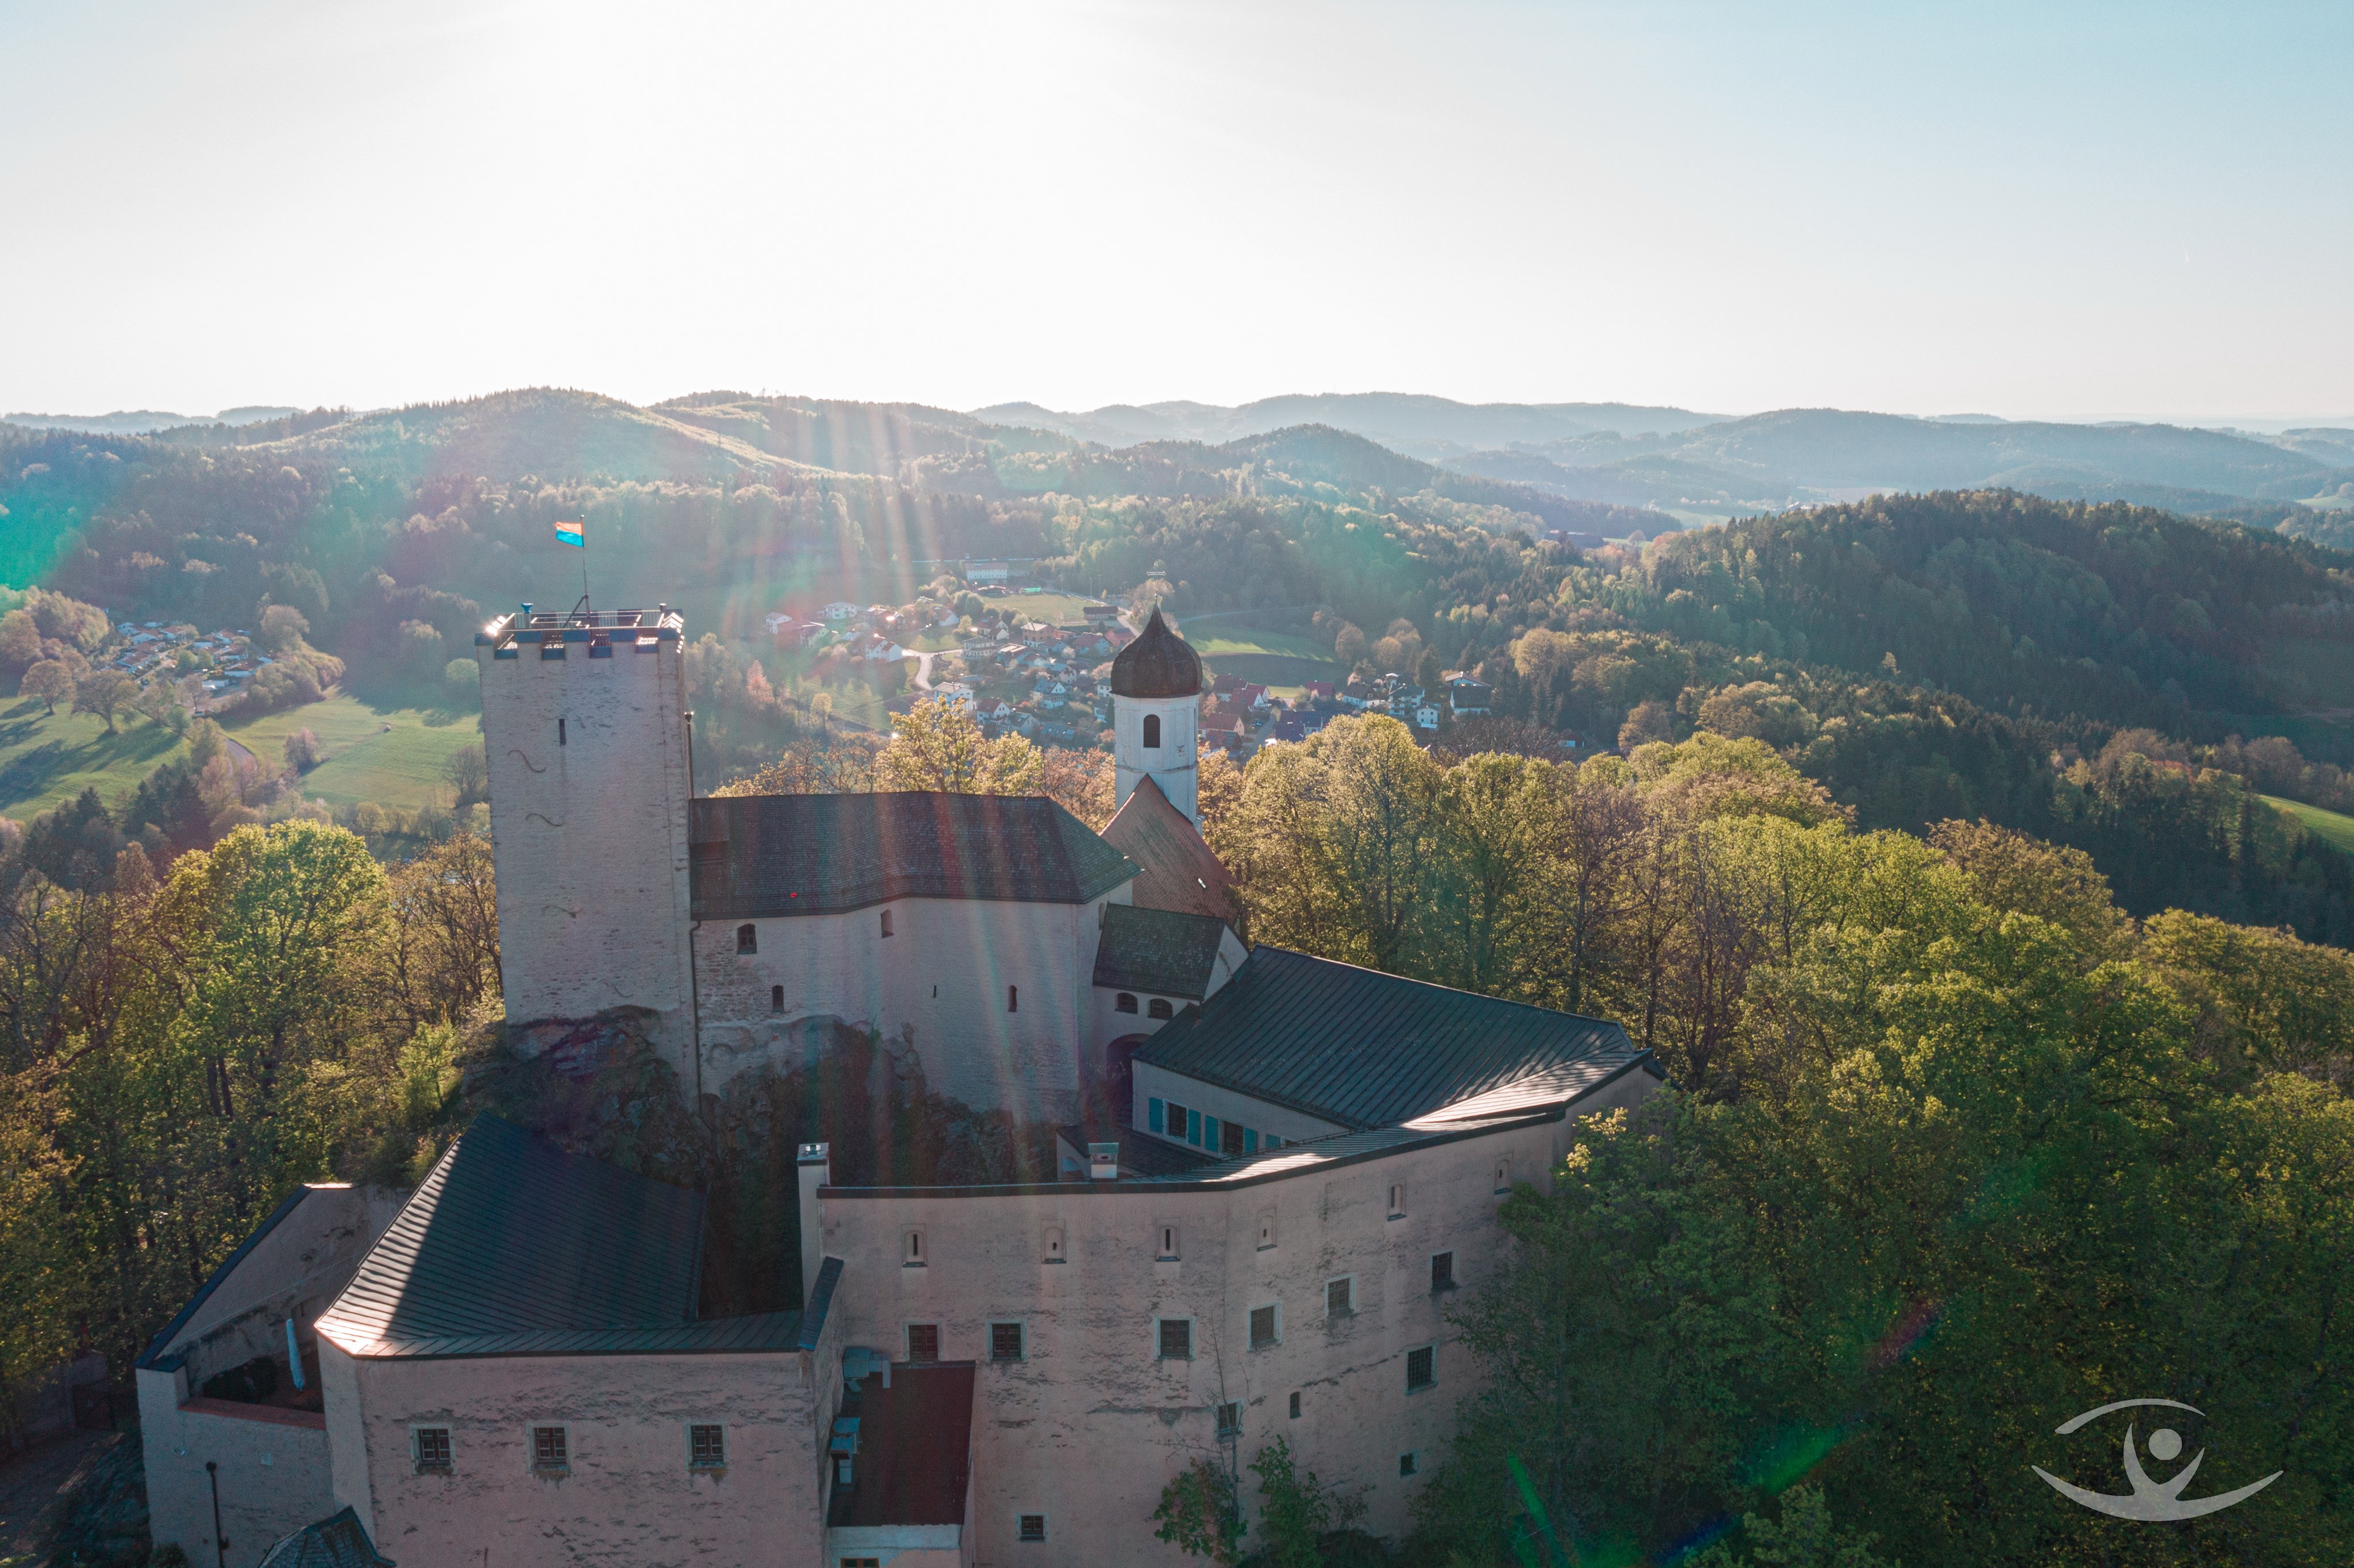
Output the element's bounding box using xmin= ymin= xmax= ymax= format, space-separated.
xmin=1137 ymin=944 xmax=1643 ymax=1130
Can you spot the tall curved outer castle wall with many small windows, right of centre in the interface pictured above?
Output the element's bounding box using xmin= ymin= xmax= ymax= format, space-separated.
xmin=819 ymin=1071 xmax=1655 ymax=1568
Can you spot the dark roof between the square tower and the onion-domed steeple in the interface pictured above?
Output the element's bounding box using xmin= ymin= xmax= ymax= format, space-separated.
xmin=687 ymin=791 xmax=1137 ymax=920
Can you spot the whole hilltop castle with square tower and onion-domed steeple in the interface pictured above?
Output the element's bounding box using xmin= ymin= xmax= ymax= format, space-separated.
xmin=139 ymin=593 xmax=1657 ymax=1568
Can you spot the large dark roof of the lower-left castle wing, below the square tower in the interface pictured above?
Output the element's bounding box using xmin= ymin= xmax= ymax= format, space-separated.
xmin=318 ymin=1116 xmax=710 ymax=1356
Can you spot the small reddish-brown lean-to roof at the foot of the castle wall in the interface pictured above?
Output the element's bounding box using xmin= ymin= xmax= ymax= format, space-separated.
xmin=826 ymin=1361 xmax=975 ymax=1530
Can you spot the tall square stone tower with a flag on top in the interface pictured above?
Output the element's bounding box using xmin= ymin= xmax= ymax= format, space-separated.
xmin=473 ymin=605 xmax=694 ymax=1069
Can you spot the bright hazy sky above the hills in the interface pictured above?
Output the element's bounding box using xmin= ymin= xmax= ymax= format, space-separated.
xmin=0 ymin=0 xmax=2354 ymax=419
